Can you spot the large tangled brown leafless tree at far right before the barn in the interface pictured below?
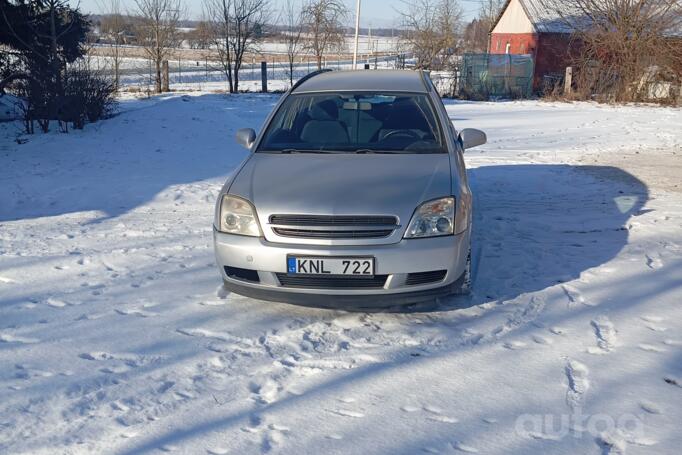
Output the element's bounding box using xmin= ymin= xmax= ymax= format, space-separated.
xmin=544 ymin=0 xmax=682 ymax=101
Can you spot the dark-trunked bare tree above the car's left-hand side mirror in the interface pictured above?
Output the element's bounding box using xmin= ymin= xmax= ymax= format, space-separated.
xmin=204 ymin=0 xmax=270 ymax=93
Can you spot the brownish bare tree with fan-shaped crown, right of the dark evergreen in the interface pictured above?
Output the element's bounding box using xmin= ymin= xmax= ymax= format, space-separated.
xmin=135 ymin=0 xmax=183 ymax=93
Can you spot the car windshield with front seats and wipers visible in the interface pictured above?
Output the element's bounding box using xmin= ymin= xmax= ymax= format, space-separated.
xmin=258 ymin=93 xmax=446 ymax=153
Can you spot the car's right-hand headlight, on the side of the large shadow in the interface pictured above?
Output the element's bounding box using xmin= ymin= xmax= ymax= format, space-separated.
xmin=405 ymin=197 xmax=455 ymax=239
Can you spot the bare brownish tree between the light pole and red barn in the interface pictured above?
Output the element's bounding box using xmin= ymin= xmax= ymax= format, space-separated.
xmin=398 ymin=0 xmax=462 ymax=69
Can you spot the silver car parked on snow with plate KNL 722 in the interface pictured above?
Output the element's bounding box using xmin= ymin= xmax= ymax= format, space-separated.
xmin=214 ymin=70 xmax=486 ymax=306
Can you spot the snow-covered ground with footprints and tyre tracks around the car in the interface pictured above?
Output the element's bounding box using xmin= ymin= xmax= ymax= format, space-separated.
xmin=0 ymin=93 xmax=682 ymax=455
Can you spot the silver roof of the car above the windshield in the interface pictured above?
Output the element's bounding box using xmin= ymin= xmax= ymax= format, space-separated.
xmin=292 ymin=70 xmax=428 ymax=93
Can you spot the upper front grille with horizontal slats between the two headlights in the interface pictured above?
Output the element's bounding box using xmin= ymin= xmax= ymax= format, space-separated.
xmin=270 ymin=215 xmax=398 ymax=239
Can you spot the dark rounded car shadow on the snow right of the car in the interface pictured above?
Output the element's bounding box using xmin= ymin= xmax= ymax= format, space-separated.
xmin=278 ymin=164 xmax=649 ymax=313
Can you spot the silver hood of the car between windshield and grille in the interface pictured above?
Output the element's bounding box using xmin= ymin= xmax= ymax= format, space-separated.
xmin=229 ymin=153 xmax=452 ymax=246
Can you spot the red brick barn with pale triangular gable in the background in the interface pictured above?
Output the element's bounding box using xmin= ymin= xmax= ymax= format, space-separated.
xmin=488 ymin=0 xmax=572 ymax=90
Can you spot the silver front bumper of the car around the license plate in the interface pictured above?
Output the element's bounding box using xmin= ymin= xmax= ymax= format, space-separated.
xmin=213 ymin=230 xmax=469 ymax=306
